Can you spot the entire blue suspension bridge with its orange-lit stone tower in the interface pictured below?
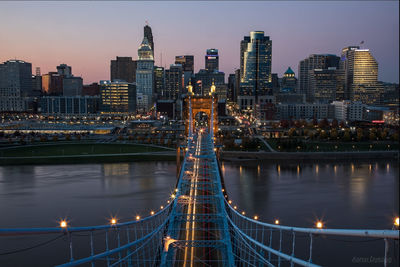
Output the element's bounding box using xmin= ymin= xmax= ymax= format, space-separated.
xmin=0 ymin=90 xmax=399 ymax=267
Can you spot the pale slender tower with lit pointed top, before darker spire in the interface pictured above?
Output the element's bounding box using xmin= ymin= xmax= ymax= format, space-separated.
xmin=136 ymin=37 xmax=154 ymax=111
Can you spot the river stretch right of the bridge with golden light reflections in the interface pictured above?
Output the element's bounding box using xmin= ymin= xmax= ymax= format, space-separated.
xmin=224 ymin=162 xmax=399 ymax=229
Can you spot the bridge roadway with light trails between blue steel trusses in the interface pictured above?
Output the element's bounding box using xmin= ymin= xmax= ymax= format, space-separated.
xmin=163 ymin=130 xmax=233 ymax=267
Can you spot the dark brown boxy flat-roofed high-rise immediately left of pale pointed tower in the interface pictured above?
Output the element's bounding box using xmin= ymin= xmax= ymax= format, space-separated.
xmin=110 ymin=57 xmax=136 ymax=83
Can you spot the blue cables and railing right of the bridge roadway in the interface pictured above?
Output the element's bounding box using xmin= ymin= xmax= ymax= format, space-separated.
xmin=225 ymin=199 xmax=399 ymax=266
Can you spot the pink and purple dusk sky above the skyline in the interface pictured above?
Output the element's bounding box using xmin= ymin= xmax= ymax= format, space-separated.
xmin=0 ymin=1 xmax=399 ymax=83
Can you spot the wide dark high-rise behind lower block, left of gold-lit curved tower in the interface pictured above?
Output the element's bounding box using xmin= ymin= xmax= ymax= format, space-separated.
xmin=298 ymin=54 xmax=339 ymax=102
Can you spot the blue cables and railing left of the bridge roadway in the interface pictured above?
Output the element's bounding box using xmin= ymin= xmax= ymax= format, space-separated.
xmin=0 ymin=204 xmax=171 ymax=266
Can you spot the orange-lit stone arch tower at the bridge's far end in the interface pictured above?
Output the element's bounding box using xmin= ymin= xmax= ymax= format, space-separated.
xmin=183 ymin=82 xmax=218 ymax=136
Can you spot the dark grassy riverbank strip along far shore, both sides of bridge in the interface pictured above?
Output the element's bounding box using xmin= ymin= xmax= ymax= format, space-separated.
xmin=0 ymin=143 xmax=399 ymax=166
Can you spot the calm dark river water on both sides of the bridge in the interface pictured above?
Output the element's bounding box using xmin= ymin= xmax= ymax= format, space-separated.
xmin=0 ymin=161 xmax=399 ymax=266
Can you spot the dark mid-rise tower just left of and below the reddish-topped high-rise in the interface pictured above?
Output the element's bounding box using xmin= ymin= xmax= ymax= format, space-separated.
xmin=165 ymin=64 xmax=183 ymax=100
